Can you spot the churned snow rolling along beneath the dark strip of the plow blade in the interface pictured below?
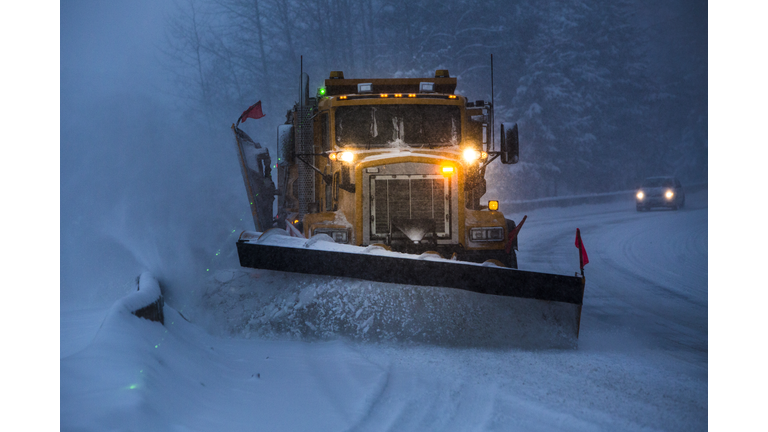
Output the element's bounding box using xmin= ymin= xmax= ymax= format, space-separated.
xmin=196 ymin=269 xmax=576 ymax=348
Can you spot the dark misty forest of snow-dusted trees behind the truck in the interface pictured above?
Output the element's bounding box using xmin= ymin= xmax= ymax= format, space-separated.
xmin=165 ymin=0 xmax=707 ymax=199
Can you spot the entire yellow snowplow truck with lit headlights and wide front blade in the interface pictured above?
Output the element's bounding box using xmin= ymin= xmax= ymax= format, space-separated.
xmin=233 ymin=70 xmax=584 ymax=334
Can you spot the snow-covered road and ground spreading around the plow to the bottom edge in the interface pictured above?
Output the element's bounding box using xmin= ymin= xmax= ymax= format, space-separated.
xmin=61 ymin=190 xmax=708 ymax=431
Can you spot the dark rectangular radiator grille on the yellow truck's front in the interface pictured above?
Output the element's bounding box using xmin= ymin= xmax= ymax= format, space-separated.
xmin=371 ymin=174 xmax=450 ymax=237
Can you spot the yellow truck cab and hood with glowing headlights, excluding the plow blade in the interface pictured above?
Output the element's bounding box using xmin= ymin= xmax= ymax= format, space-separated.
xmin=277 ymin=70 xmax=518 ymax=267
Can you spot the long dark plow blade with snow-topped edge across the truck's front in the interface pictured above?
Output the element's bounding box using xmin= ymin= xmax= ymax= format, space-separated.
xmin=237 ymin=229 xmax=584 ymax=337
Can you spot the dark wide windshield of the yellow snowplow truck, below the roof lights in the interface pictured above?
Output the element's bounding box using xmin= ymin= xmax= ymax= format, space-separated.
xmin=336 ymin=105 xmax=461 ymax=148
